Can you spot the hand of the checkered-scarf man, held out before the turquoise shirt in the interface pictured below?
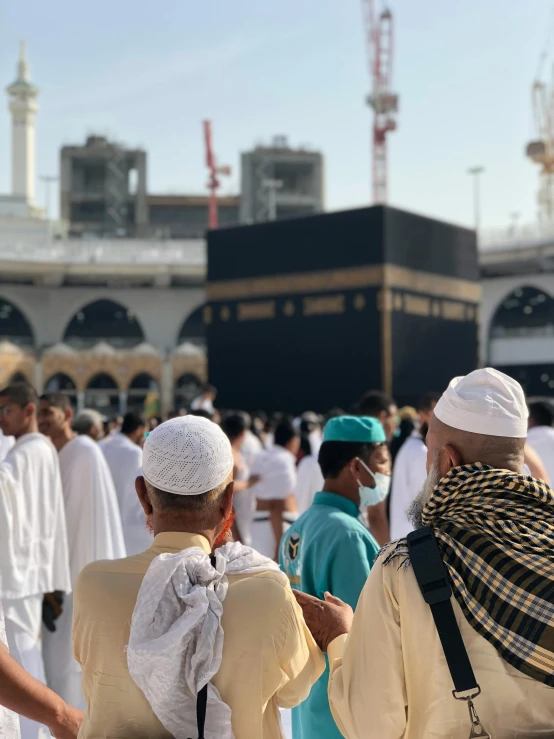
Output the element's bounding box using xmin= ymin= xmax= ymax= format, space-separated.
xmin=292 ymin=590 xmax=354 ymax=652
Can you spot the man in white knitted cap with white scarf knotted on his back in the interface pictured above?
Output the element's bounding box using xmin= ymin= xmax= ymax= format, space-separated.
xmin=74 ymin=416 xmax=324 ymax=739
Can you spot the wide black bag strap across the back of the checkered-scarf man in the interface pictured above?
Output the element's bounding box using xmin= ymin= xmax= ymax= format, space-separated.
xmin=408 ymin=527 xmax=481 ymax=698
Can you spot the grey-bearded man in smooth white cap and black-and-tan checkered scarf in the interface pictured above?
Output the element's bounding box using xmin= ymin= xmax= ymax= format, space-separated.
xmin=292 ymin=368 xmax=554 ymax=739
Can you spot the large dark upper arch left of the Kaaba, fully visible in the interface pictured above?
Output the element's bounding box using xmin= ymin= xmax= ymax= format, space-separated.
xmin=63 ymin=298 xmax=145 ymax=349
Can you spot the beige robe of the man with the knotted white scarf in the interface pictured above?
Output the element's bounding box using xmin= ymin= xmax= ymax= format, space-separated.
xmin=73 ymin=532 xmax=325 ymax=739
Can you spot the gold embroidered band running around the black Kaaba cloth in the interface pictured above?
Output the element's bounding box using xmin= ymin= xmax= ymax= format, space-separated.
xmin=206 ymin=264 xmax=481 ymax=303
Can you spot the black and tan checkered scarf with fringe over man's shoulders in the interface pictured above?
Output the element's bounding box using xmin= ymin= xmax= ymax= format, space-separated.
xmin=383 ymin=463 xmax=554 ymax=687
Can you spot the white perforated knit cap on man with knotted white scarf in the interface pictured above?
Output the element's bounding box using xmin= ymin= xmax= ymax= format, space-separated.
xmin=142 ymin=416 xmax=234 ymax=495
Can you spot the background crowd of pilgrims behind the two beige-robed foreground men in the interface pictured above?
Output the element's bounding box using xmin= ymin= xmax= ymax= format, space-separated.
xmin=0 ymin=376 xmax=554 ymax=739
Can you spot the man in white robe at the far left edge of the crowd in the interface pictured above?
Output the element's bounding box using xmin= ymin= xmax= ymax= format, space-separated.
xmin=0 ymin=384 xmax=71 ymax=739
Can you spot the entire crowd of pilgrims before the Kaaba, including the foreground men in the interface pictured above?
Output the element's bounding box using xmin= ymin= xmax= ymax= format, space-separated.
xmin=0 ymin=370 xmax=554 ymax=739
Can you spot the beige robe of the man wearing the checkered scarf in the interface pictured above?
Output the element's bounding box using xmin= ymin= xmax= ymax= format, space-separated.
xmin=328 ymin=559 xmax=554 ymax=739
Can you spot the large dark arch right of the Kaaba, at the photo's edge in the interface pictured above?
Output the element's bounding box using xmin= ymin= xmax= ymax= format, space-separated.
xmin=489 ymin=285 xmax=554 ymax=340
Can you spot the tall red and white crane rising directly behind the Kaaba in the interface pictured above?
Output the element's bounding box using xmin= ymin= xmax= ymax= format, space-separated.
xmin=362 ymin=0 xmax=398 ymax=203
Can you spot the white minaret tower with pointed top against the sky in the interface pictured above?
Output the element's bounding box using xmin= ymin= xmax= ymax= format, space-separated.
xmin=6 ymin=41 xmax=38 ymax=204
